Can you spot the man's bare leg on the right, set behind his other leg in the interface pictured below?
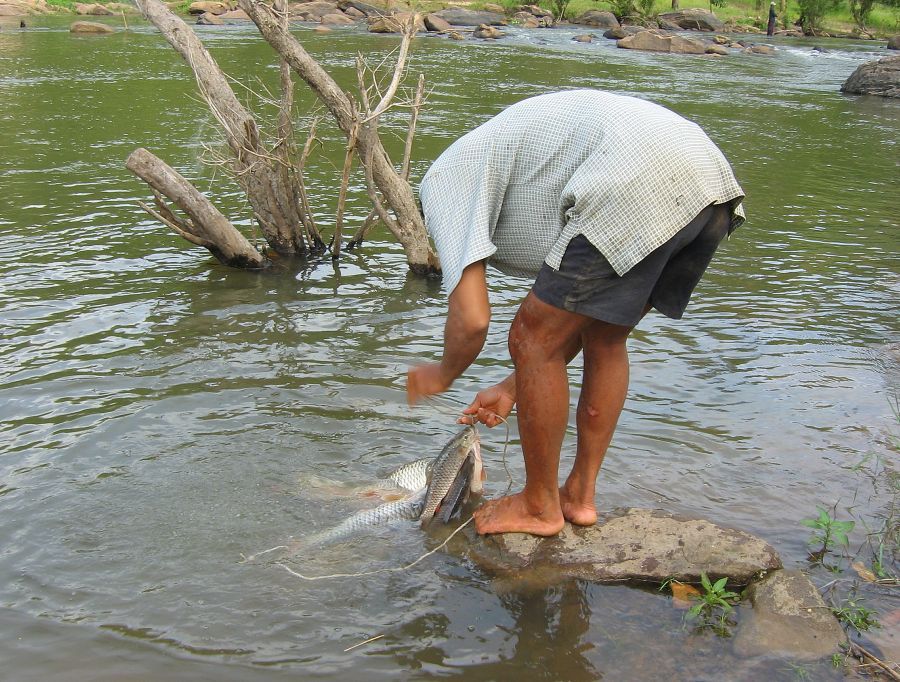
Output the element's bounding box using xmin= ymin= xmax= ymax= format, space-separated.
xmin=559 ymin=321 xmax=631 ymax=526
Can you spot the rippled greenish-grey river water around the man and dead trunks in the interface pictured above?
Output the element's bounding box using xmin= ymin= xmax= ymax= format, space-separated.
xmin=0 ymin=19 xmax=900 ymax=680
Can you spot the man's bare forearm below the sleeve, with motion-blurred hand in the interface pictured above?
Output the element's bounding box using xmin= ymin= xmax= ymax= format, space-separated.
xmin=406 ymin=261 xmax=491 ymax=405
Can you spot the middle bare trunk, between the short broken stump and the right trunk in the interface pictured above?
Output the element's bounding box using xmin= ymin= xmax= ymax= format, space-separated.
xmin=136 ymin=0 xmax=321 ymax=254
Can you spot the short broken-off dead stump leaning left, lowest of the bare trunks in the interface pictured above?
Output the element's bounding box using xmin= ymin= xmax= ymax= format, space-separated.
xmin=125 ymin=148 xmax=267 ymax=268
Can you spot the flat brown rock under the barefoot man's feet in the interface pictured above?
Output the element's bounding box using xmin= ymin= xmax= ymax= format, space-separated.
xmin=466 ymin=509 xmax=781 ymax=585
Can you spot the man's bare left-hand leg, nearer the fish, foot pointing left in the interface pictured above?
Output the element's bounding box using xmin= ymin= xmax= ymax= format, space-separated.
xmin=475 ymin=294 xmax=594 ymax=535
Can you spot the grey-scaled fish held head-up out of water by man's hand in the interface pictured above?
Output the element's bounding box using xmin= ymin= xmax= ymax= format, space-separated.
xmin=419 ymin=425 xmax=484 ymax=528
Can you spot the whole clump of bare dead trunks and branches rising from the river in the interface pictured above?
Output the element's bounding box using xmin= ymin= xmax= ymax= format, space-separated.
xmin=128 ymin=0 xmax=440 ymax=275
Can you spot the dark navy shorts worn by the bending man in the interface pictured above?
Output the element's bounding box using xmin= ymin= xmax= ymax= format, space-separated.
xmin=532 ymin=204 xmax=731 ymax=327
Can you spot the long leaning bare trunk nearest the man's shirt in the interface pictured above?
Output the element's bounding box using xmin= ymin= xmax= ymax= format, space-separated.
xmin=237 ymin=0 xmax=440 ymax=275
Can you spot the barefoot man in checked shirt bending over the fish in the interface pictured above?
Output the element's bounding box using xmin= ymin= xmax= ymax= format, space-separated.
xmin=406 ymin=90 xmax=744 ymax=535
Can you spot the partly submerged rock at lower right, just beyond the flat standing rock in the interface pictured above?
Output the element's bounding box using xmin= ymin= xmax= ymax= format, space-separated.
xmin=734 ymin=571 xmax=847 ymax=660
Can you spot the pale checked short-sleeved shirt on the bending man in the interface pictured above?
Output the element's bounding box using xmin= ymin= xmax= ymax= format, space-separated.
xmin=419 ymin=90 xmax=744 ymax=293
